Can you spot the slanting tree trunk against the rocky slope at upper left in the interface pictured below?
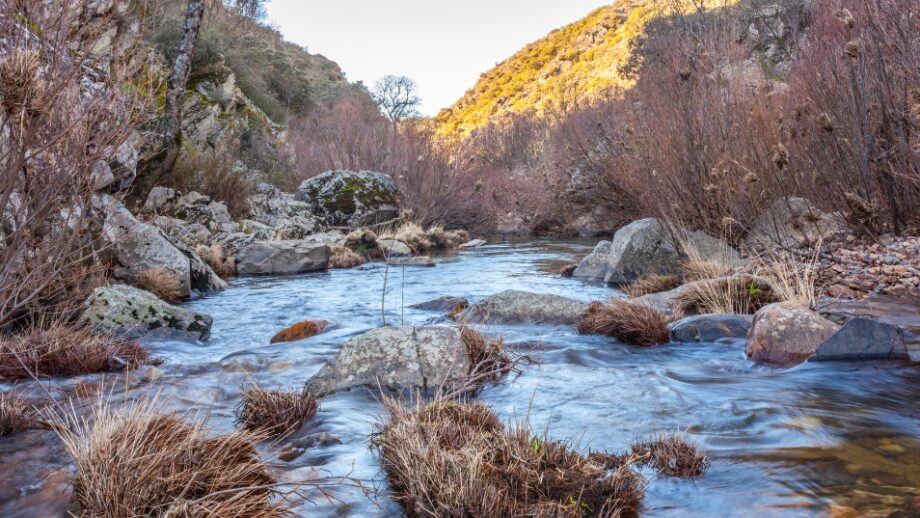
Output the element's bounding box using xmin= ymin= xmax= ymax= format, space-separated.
xmin=156 ymin=0 xmax=204 ymax=181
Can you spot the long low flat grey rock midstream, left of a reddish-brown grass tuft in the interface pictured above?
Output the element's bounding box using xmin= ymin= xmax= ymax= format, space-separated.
xmin=457 ymin=290 xmax=588 ymax=325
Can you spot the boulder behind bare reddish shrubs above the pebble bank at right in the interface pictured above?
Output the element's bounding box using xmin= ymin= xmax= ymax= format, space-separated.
xmin=747 ymin=197 xmax=847 ymax=248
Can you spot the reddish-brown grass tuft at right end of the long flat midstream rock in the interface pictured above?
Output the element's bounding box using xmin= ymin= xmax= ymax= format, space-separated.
xmin=577 ymin=299 xmax=671 ymax=347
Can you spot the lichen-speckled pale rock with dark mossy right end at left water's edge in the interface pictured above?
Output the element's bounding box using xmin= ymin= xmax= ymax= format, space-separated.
xmin=81 ymin=285 xmax=213 ymax=340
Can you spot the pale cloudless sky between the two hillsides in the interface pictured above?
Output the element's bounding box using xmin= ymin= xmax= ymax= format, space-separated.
xmin=267 ymin=0 xmax=610 ymax=115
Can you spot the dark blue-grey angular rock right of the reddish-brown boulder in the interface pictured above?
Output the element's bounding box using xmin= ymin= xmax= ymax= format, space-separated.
xmin=811 ymin=318 xmax=910 ymax=361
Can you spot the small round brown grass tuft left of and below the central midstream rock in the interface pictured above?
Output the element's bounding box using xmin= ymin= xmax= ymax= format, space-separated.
xmin=236 ymin=387 xmax=319 ymax=438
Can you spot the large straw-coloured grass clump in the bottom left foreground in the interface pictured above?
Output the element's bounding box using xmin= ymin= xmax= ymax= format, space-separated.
xmin=51 ymin=400 xmax=289 ymax=518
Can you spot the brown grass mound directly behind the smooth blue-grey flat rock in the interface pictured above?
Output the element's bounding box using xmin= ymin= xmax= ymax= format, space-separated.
xmin=677 ymin=275 xmax=777 ymax=315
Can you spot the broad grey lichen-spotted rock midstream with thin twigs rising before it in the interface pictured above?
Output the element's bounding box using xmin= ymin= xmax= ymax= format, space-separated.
xmin=307 ymin=326 xmax=469 ymax=394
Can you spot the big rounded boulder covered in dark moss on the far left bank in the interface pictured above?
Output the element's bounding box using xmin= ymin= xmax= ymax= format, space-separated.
xmin=297 ymin=170 xmax=399 ymax=227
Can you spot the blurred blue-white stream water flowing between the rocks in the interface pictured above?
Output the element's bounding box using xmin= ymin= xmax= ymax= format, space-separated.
xmin=0 ymin=242 xmax=920 ymax=517
